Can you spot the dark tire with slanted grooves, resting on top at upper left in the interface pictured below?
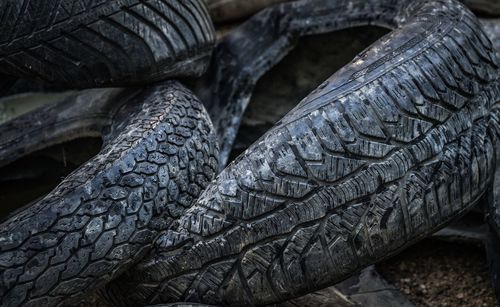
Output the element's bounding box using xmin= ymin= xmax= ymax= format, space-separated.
xmin=0 ymin=0 xmax=215 ymax=88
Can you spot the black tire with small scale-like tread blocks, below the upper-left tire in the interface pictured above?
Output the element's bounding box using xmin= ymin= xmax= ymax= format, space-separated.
xmin=0 ymin=82 xmax=217 ymax=306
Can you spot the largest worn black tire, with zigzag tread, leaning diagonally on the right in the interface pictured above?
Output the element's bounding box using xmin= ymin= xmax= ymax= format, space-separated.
xmin=105 ymin=0 xmax=500 ymax=306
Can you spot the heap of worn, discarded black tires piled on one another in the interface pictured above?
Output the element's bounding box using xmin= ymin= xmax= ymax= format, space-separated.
xmin=0 ymin=0 xmax=500 ymax=306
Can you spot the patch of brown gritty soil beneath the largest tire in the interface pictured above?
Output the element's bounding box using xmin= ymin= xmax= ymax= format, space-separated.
xmin=377 ymin=238 xmax=499 ymax=306
